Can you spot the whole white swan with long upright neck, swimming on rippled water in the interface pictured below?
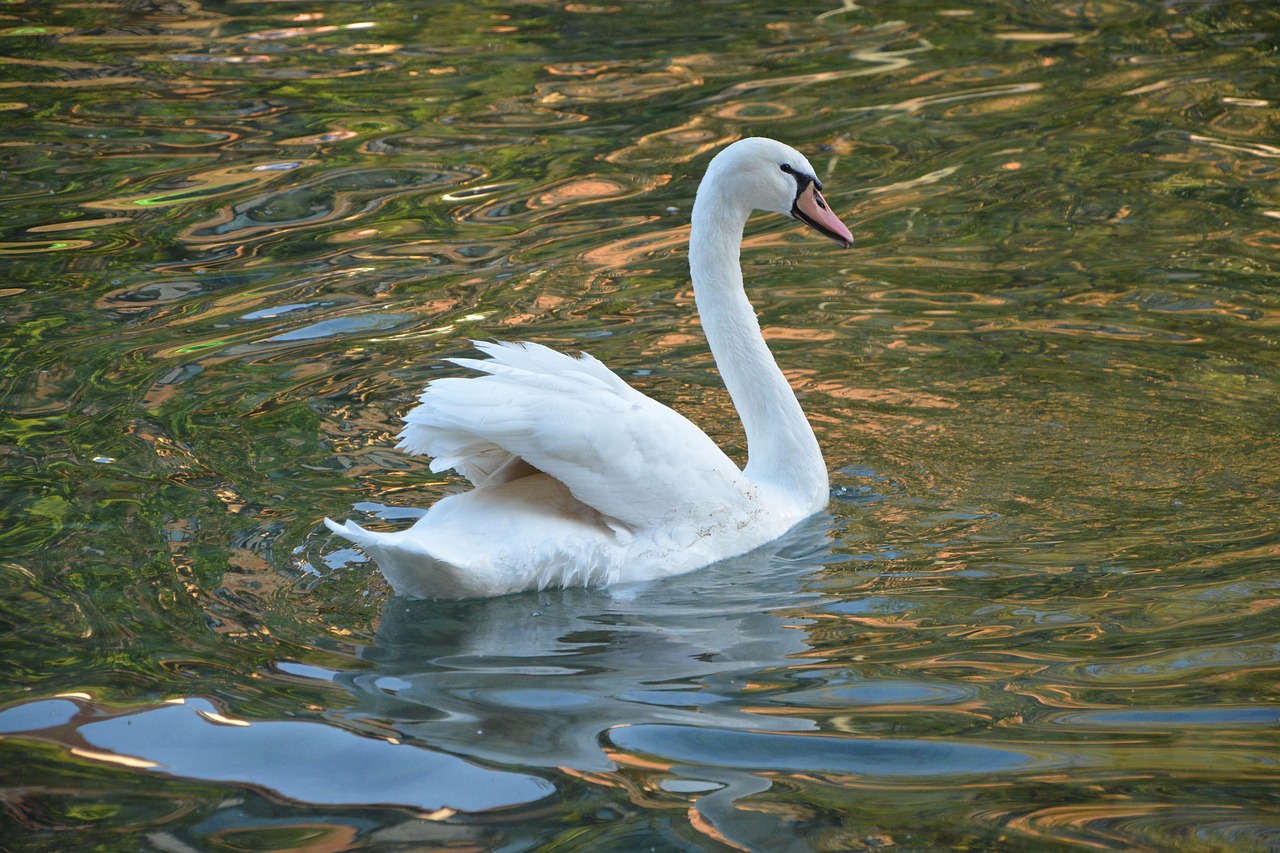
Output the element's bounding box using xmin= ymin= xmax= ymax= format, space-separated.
xmin=325 ymin=137 xmax=854 ymax=598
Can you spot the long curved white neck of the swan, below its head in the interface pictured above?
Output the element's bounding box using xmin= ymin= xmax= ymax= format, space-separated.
xmin=689 ymin=189 xmax=828 ymax=515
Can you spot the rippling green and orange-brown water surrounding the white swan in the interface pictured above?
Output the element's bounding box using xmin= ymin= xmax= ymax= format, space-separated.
xmin=0 ymin=1 xmax=1280 ymax=852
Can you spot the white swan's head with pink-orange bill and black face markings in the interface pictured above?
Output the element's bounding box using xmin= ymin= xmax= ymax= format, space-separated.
xmin=699 ymin=136 xmax=854 ymax=248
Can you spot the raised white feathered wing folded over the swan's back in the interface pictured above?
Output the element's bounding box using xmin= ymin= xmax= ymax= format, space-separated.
xmin=399 ymin=343 xmax=751 ymax=526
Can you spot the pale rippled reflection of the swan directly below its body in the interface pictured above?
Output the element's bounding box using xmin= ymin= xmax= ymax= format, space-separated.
xmin=338 ymin=515 xmax=832 ymax=771
